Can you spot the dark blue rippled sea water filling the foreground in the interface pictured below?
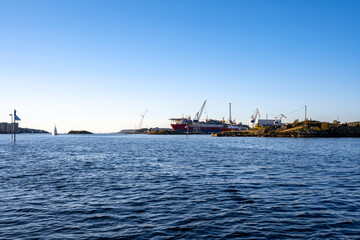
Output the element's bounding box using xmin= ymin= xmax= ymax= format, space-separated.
xmin=0 ymin=134 xmax=360 ymax=239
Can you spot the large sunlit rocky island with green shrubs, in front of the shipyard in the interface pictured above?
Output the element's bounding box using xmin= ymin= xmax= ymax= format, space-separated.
xmin=212 ymin=121 xmax=360 ymax=138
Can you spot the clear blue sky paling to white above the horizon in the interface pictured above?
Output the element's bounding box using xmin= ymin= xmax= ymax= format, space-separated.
xmin=0 ymin=0 xmax=360 ymax=132
